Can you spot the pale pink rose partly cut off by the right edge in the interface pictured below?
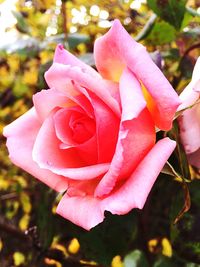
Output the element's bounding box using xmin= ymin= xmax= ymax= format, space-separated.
xmin=178 ymin=57 xmax=200 ymax=168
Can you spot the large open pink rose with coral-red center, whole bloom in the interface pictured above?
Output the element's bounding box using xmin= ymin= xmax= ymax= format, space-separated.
xmin=4 ymin=20 xmax=179 ymax=230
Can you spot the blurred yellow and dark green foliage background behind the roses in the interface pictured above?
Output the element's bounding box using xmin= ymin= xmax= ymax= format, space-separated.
xmin=0 ymin=0 xmax=200 ymax=267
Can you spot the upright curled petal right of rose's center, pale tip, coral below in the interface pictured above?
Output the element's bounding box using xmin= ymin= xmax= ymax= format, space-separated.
xmin=95 ymin=69 xmax=155 ymax=197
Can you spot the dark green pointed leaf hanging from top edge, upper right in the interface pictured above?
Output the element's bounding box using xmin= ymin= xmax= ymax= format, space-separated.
xmin=147 ymin=0 xmax=187 ymax=29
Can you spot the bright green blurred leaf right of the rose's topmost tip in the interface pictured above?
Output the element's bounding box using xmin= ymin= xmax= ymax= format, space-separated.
xmin=147 ymin=21 xmax=176 ymax=45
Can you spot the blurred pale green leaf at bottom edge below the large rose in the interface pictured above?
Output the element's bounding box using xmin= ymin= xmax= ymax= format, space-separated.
xmin=124 ymin=250 xmax=149 ymax=267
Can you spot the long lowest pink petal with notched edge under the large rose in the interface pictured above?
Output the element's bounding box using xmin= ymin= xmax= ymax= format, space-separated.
xmin=56 ymin=138 xmax=176 ymax=230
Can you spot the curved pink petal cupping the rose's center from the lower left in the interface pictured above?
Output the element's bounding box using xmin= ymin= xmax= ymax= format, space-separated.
xmin=33 ymin=117 xmax=109 ymax=180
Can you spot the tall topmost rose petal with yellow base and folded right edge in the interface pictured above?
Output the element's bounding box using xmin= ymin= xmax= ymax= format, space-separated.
xmin=94 ymin=20 xmax=180 ymax=130
